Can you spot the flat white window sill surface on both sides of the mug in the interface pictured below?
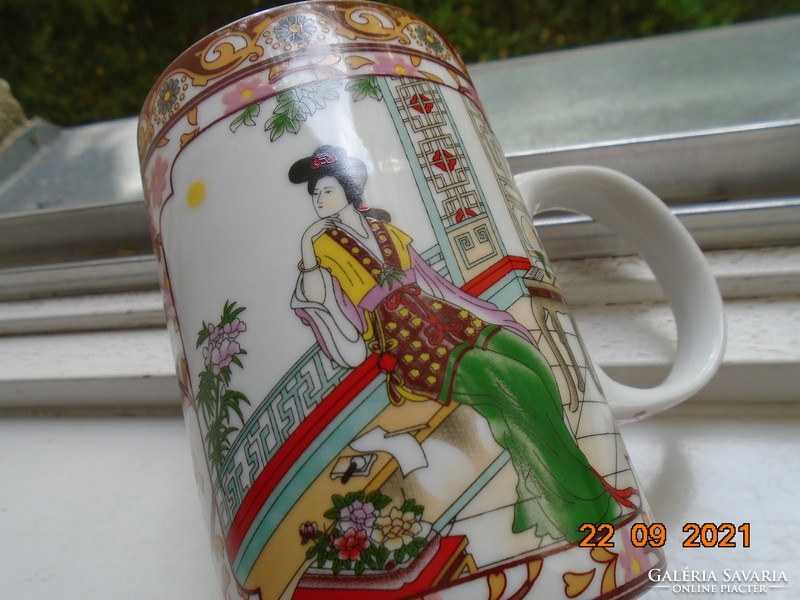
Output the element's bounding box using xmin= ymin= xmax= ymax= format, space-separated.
xmin=0 ymin=403 xmax=800 ymax=600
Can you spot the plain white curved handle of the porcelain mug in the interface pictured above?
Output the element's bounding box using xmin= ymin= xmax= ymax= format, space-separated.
xmin=515 ymin=167 xmax=725 ymax=421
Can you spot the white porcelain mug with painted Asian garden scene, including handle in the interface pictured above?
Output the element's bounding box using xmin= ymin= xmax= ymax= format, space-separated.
xmin=139 ymin=1 xmax=724 ymax=600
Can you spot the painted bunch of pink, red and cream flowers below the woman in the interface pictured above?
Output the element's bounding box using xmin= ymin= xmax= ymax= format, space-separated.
xmin=300 ymin=491 xmax=430 ymax=575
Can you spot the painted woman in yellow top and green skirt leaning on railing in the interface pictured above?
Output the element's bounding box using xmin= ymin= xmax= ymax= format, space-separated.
xmin=289 ymin=146 xmax=627 ymax=541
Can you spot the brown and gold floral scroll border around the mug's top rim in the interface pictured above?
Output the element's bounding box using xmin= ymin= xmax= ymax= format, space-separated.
xmin=138 ymin=1 xmax=478 ymax=165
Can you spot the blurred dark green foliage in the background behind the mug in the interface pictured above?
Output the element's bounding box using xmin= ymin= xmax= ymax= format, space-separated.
xmin=0 ymin=0 xmax=800 ymax=126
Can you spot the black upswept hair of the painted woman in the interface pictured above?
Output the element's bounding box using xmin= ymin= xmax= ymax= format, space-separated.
xmin=289 ymin=146 xmax=391 ymax=222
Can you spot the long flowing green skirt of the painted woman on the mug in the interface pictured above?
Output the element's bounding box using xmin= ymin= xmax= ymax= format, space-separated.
xmin=439 ymin=326 xmax=620 ymax=541
